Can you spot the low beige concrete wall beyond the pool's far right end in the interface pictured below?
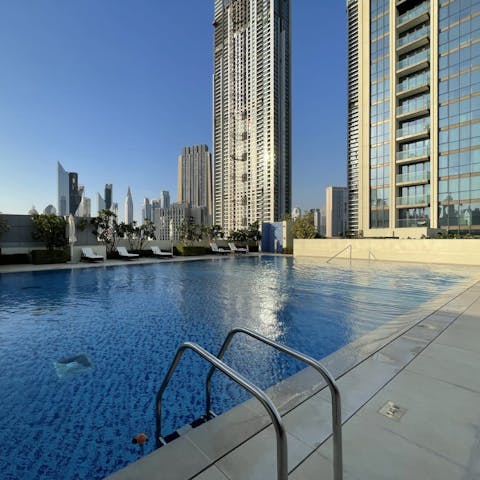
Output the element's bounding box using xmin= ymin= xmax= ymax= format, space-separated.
xmin=293 ymin=238 xmax=480 ymax=266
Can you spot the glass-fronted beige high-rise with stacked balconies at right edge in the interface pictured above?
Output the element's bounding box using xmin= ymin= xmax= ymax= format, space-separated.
xmin=347 ymin=0 xmax=480 ymax=237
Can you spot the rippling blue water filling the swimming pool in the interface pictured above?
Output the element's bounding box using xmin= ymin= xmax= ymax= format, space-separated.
xmin=0 ymin=257 xmax=464 ymax=480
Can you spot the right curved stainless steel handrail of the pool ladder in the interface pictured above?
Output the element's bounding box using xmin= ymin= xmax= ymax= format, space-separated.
xmin=206 ymin=328 xmax=343 ymax=480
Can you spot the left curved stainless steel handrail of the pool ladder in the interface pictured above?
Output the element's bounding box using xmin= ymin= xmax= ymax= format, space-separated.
xmin=156 ymin=342 xmax=288 ymax=480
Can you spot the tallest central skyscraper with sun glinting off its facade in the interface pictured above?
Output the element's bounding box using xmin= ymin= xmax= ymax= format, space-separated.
xmin=213 ymin=0 xmax=291 ymax=231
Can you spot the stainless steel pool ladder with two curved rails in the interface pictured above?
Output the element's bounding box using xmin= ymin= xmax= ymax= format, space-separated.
xmin=155 ymin=328 xmax=343 ymax=480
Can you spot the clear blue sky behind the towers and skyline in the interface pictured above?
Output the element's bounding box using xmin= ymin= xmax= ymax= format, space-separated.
xmin=0 ymin=0 xmax=346 ymax=220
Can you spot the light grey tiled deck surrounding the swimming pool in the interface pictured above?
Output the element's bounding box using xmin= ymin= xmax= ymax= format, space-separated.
xmin=0 ymin=257 xmax=480 ymax=480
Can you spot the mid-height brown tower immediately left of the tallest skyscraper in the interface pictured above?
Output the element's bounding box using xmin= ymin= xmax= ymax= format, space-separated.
xmin=178 ymin=145 xmax=212 ymax=216
